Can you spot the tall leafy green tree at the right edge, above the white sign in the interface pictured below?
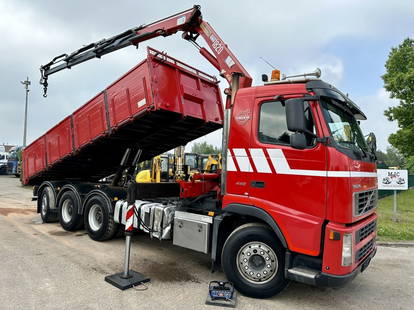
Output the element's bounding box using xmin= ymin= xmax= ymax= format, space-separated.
xmin=382 ymin=38 xmax=414 ymax=158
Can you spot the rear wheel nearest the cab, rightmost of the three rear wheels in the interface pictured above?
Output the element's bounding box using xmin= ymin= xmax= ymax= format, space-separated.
xmin=84 ymin=195 xmax=119 ymax=241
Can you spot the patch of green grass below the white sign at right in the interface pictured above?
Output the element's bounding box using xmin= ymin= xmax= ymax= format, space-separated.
xmin=378 ymin=189 xmax=414 ymax=241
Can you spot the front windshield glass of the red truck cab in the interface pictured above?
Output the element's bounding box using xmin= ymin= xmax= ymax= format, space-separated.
xmin=322 ymin=100 xmax=368 ymax=153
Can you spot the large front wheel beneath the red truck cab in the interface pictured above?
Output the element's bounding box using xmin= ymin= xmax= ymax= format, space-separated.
xmin=221 ymin=223 xmax=289 ymax=298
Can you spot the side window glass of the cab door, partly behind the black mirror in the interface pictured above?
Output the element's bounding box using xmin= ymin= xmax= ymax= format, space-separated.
xmin=259 ymin=101 xmax=316 ymax=146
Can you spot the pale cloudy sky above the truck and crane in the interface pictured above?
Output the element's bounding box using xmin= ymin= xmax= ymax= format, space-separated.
xmin=0 ymin=0 xmax=414 ymax=150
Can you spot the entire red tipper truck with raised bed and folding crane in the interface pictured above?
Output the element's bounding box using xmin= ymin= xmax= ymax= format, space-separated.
xmin=23 ymin=6 xmax=377 ymax=298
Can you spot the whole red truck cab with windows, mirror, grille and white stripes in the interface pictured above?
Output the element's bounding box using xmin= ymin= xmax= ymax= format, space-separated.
xmin=223 ymin=79 xmax=377 ymax=285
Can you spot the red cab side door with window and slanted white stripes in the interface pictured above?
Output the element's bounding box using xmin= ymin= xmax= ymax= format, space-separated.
xmin=248 ymin=97 xmax=327 ymax=254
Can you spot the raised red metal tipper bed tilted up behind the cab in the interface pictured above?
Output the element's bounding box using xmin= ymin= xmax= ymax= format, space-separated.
xmin=23 ymin=48 xmax=223 ymax=184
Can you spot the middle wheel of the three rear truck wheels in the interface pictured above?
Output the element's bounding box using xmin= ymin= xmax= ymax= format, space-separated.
xmin=58 ymin=190 xmax=83 ymax=231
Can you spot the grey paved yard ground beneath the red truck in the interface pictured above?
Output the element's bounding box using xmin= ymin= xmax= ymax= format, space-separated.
xmin=0 ymin=176 xmax=414 ymax=310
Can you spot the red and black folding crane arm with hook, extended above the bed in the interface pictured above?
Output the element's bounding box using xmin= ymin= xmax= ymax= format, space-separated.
xmin=40 ymin=5 xmax=252 ymax=97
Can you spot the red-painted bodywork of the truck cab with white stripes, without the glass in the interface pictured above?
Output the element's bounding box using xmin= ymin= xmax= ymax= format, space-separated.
xmin=223 ymin=83 xmax=377 ymax=276
